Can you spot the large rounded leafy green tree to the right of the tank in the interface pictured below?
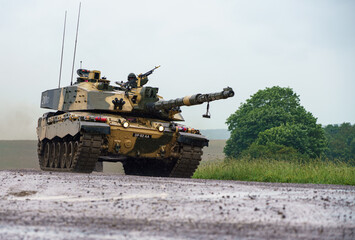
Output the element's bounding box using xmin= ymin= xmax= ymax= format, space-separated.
xmin=224 ymin=86 xmax=326 ymax=158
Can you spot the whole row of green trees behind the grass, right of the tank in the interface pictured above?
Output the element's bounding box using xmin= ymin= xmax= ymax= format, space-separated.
xmin=224 ymin=86 xmax=355 ymax=162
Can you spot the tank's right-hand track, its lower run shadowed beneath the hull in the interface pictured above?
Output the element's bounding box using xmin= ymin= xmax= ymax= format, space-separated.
xmin=123 ymin=145 xmax=202 ymax=178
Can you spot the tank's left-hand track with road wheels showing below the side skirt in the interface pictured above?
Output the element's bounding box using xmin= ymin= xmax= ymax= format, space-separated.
xmin=37 ymin=133 xmax=102 ymax=173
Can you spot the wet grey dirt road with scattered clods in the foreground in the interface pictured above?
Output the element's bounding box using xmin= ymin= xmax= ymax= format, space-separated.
xmin=0 ymin=170 xmax=355 ymax=239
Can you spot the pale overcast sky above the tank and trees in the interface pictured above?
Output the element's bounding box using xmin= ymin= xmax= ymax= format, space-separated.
xmin=0 ymin=0 xmax=355 ymax=139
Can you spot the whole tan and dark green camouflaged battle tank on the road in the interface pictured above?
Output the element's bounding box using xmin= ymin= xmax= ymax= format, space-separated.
xmin=37 ymin=67 xmax=234 ymax=177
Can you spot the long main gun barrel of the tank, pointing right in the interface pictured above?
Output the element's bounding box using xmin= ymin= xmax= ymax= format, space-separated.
xmin=147 ymin=87 xmax=234 ymax=111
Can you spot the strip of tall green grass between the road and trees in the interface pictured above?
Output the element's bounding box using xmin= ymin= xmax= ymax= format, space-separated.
xmin=193 ymin=158 xmax=355 ymax=185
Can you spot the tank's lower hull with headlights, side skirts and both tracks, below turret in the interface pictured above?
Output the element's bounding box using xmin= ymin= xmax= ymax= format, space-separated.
xmin=37 ymin=112 xmax=208 ymax=177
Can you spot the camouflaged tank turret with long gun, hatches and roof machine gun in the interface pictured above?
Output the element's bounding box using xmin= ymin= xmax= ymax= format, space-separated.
xmin=41 ymin=67 xmax=234 ymax=121
